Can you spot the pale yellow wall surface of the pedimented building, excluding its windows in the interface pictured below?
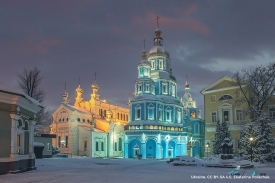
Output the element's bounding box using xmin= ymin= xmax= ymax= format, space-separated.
xmin=204 ymin=79 xmax=275 ymax=155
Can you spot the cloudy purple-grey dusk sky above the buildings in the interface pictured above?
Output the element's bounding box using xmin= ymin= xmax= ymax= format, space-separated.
xmin=0 ymin=0 xmax=275 ymax=118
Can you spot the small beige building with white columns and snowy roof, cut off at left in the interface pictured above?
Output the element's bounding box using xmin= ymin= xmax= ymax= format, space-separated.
xmin=0 ymin=89 xmax=43 ymax=174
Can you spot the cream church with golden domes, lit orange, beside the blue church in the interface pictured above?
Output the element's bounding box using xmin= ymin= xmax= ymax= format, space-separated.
xmin=50 ymin=82 xmax=129 ymax=157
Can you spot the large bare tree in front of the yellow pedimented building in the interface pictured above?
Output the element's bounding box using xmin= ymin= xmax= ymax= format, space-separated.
xmin=234 ymin=63 xmax=275 ymax=119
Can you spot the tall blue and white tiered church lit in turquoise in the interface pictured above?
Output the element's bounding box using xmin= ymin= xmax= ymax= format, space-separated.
xmin=124 ymin=28 xmax=204 ymax=159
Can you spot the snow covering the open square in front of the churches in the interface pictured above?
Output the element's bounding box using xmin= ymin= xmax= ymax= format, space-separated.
xmin=0 ymin=157 xmax=275 ymax=183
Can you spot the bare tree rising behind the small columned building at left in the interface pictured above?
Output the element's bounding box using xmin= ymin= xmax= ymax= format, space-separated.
xmin=17 ymin=67 xmax=50 ymax=132
